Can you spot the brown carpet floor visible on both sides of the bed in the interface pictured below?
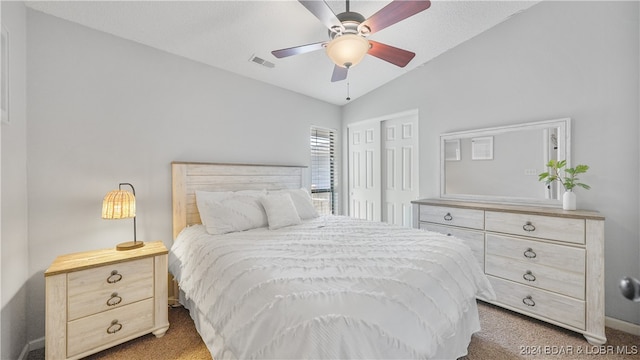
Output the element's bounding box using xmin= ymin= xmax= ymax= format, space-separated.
xmin=28 ymin=303 xmax=640 ymax=360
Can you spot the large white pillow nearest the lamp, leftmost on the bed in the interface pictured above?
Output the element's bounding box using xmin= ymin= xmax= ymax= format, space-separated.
xmin=196 ymin=190 xmax=268 ymax=235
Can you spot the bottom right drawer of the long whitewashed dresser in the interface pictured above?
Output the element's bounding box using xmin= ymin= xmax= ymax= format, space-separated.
xmin=488 ymin=276 xmax=585 ymax=330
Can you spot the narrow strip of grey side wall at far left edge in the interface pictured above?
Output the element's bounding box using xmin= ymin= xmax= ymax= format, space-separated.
xmin=0 ymin=1 xmax=29 ymax=359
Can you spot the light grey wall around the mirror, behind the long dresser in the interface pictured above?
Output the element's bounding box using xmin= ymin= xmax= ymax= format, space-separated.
xmin=343 ymin=1 xmax=640 ymax=324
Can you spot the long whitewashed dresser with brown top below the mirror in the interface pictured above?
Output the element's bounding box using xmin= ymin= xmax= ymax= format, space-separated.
xmin=413 ymin=199 xmax=606 ymax=345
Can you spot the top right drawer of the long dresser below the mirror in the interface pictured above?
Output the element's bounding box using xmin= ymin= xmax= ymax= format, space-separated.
xmin=485 ymin=211 xmax=585 ymax=244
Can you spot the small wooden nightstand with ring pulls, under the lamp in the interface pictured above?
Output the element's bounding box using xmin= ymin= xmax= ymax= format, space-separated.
xmin=44 ymin=241 xmax=169 ymax=360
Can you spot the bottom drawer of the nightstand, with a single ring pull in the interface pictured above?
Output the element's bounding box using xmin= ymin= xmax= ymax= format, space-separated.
xmin=67 ymin=299 xmax=154 ymax=357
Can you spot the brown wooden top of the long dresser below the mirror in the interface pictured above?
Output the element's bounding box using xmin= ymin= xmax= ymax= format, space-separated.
xmin=411 ymin=199 xmax=604 ymax=220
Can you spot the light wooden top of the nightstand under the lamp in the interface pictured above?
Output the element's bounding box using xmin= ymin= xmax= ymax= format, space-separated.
xmin=44 ymin=241 xmax=169 ymax=276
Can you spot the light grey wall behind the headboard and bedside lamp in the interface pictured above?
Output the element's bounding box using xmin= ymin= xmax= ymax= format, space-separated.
xmin=27 ymin=10 xmax=340 ymax=339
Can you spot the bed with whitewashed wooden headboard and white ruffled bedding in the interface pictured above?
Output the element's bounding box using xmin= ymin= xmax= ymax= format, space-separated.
xmin=169 ymin=162 xmax=495 ymax=360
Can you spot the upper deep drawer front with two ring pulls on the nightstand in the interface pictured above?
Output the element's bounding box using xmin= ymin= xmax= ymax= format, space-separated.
xmin=67 ymin=258 xmax=154 ymax=320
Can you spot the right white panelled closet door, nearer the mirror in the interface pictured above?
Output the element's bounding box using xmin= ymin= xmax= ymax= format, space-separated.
xmin=381 ymin=114 xmax=419 ymax=227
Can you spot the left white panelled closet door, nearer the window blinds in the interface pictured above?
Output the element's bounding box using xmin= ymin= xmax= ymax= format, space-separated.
xmin=348 ymin=121 xmax=381 ymax=221
